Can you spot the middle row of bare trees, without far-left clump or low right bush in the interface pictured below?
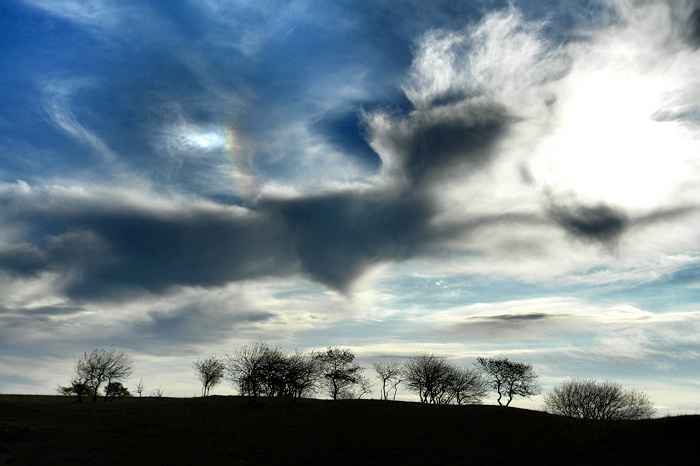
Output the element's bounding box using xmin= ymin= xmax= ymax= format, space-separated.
xmin=193 ymin=341 xmax=539 ymax=406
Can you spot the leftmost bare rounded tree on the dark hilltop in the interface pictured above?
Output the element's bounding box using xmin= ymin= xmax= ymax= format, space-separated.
xmin=71 ymin=349 xmax=133 ymax=401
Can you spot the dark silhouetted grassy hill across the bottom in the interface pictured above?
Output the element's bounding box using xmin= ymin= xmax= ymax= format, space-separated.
xmin=0 ymin=395 xmax=700 ymax=466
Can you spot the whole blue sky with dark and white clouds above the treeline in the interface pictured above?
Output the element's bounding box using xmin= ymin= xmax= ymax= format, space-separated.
xmin=0 ymin=0 xmax=700 ymax=415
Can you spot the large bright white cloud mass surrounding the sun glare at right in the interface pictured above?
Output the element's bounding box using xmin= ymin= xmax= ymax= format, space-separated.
xmin=358 ymin=2 xmax=700 ymax=283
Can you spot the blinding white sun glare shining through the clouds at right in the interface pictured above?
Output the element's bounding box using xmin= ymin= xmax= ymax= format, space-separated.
xmin=532 ymin=72 xmax=690 ymax=208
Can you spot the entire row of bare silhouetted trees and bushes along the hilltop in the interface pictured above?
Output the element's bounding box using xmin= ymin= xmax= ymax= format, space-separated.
xmin=58 ymin=341 xmax=655 ymax=420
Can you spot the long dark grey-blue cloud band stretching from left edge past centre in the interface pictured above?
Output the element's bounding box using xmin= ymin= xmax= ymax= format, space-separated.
xmin=0 ymin=181 xmax=437 ymax=299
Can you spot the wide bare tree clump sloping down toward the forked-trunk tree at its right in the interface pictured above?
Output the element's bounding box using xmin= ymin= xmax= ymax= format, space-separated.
xmin=403 ymin=352 xmax=486 ymax=404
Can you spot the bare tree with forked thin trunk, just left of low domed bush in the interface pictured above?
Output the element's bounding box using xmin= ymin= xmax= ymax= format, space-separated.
xmin=476 ymin=357 xmax=540 ymax=406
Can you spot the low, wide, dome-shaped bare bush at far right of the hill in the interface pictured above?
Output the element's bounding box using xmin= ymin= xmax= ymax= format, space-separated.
xmin=544 ymin=379 xmax=656 ymax=420
